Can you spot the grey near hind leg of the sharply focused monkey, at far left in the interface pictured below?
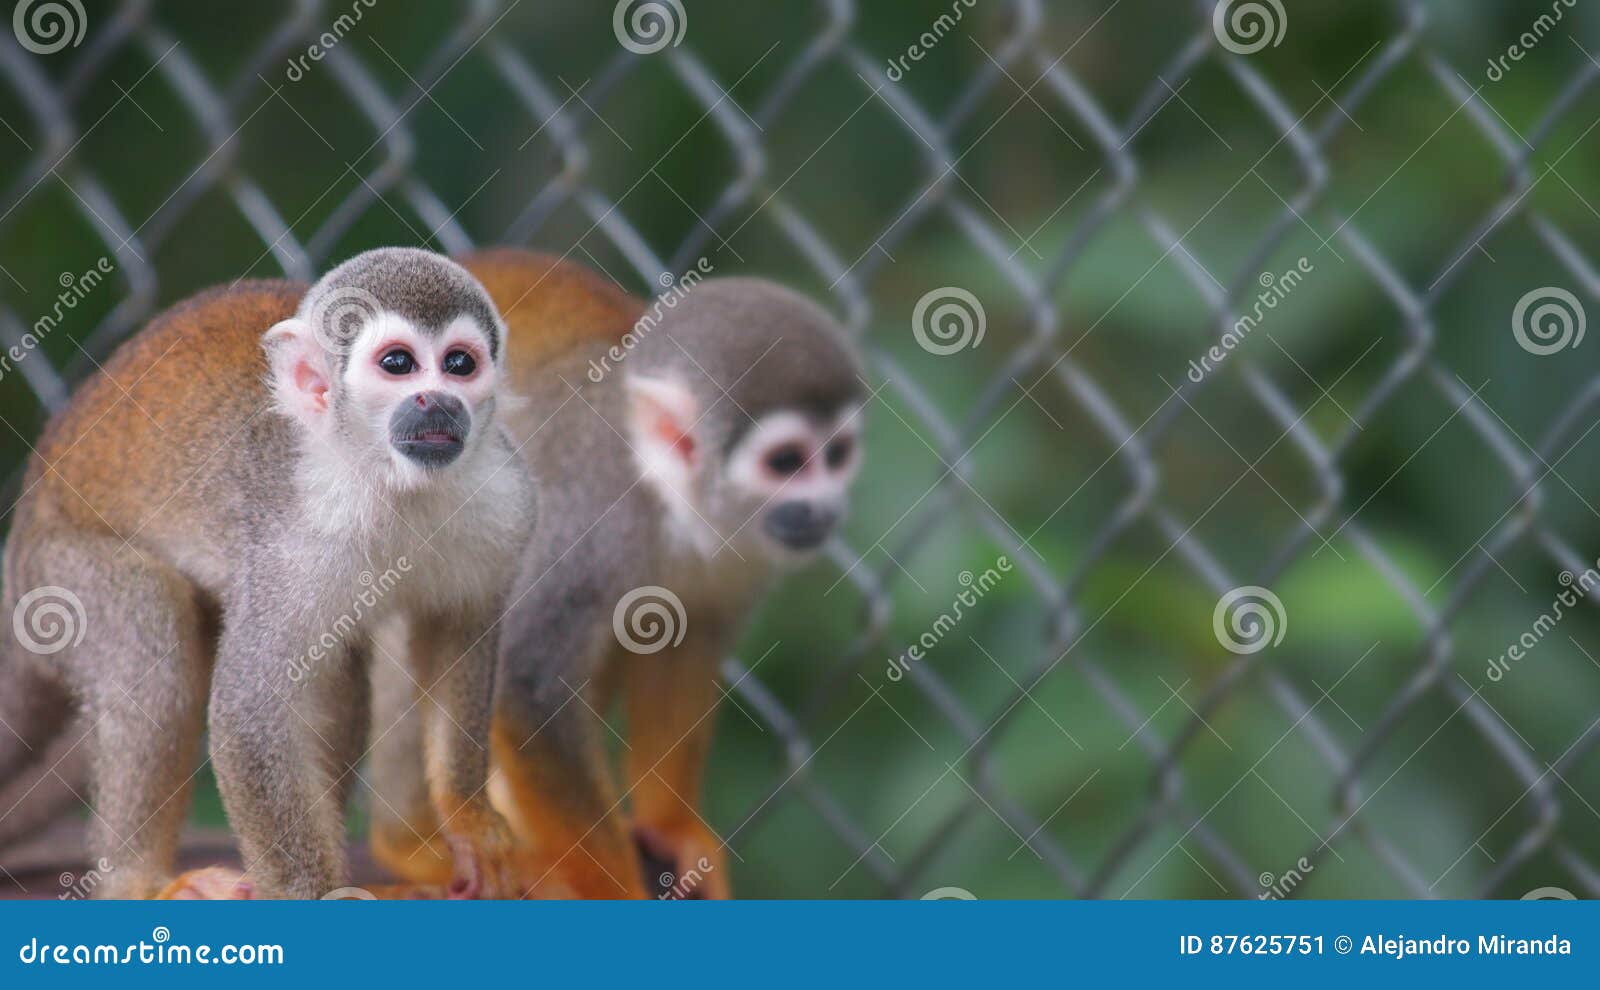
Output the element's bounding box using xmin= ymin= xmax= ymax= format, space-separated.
xmin=13 ymin=533 xmax=210 ymax=899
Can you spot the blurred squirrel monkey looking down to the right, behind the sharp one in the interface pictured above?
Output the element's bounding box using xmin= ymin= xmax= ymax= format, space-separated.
xmin=373 ymin=249 xmax=866 ymax=897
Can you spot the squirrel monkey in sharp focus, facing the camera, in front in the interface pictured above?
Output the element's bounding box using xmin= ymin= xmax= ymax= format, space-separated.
xmin=0 ymin=248 xmax=533 ymax=897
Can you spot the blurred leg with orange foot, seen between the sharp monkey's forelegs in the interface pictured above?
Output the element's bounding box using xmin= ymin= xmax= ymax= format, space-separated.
xmin=366 ymin=622 xmax=453 ymax=884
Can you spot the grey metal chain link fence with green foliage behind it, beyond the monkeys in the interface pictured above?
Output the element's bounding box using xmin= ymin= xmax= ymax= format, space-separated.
xmin=0 ymin=0 xmax=1600 ymax=897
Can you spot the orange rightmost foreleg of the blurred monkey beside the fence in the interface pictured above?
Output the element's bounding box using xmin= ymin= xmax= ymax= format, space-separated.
xmin=622 ymin=635 xmax=730 ymax=899
